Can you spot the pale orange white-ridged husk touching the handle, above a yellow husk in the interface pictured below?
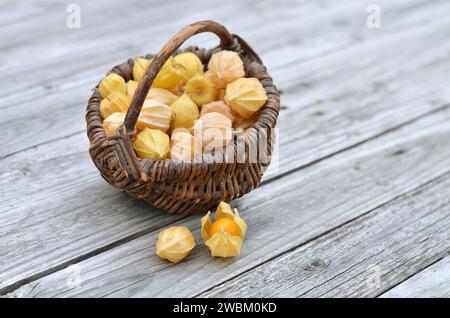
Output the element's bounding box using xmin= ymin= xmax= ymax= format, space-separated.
xmin=136 ymin=100 xmax=174 ymax=132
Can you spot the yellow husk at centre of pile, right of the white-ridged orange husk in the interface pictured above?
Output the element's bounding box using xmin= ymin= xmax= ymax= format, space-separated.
xmin=170 ymin=94 xmax=200 ymax=129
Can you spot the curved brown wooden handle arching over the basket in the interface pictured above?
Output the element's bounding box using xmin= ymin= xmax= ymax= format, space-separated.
xmin=124 ymin=21 xmax=234 ymax=134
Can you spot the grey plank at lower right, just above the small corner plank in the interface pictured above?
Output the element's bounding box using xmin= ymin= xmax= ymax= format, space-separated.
xmin=200 ymin=174 xmax=450 ymax=298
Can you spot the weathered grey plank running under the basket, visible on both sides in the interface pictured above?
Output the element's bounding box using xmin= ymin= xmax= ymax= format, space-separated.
xmin=0 ymin=10 xmax=450 ymax=294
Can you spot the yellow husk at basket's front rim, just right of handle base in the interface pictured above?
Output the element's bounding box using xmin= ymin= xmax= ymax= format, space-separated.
xmin=133 ymin=128 xmax=170 ymax=160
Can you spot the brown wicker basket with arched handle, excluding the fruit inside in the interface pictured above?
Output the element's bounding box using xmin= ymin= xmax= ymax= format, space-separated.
xmin=86 ymin=21 xmax=280 ymax=214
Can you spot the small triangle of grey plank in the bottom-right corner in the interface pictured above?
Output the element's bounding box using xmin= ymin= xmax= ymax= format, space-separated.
xmin=381 ymin=256 xmax=450 ymax=298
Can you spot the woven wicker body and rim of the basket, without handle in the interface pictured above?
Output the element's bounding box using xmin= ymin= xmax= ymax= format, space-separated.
xmin=86 ymin=39 xmax=280 ymax=213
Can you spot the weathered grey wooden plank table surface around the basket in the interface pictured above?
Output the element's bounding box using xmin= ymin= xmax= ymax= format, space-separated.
xmin=0 ymin=0 xmax=450 ymax=297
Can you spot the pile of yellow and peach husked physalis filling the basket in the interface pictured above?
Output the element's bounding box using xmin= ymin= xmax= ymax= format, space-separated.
xmin=98 ymin=50 xmax=267 ymax=161
